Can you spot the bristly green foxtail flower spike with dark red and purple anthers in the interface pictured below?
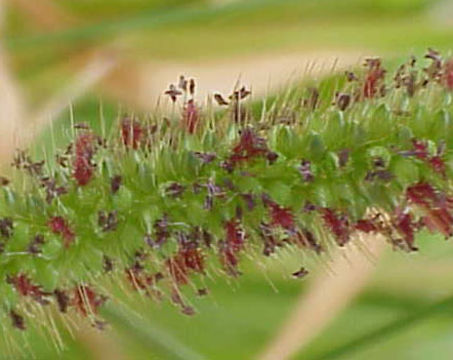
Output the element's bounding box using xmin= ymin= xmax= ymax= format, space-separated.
xmin=0 ymin=50 xmax=453 ymax=340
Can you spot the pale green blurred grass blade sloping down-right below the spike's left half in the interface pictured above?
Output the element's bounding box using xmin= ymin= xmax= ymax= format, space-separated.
xmin=102 ymin=304 xmax=205 ymax=360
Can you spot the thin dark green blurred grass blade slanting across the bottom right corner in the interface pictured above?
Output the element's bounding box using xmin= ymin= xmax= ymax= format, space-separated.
xmin=303 ymin=296 xmax=453 ymax=360
